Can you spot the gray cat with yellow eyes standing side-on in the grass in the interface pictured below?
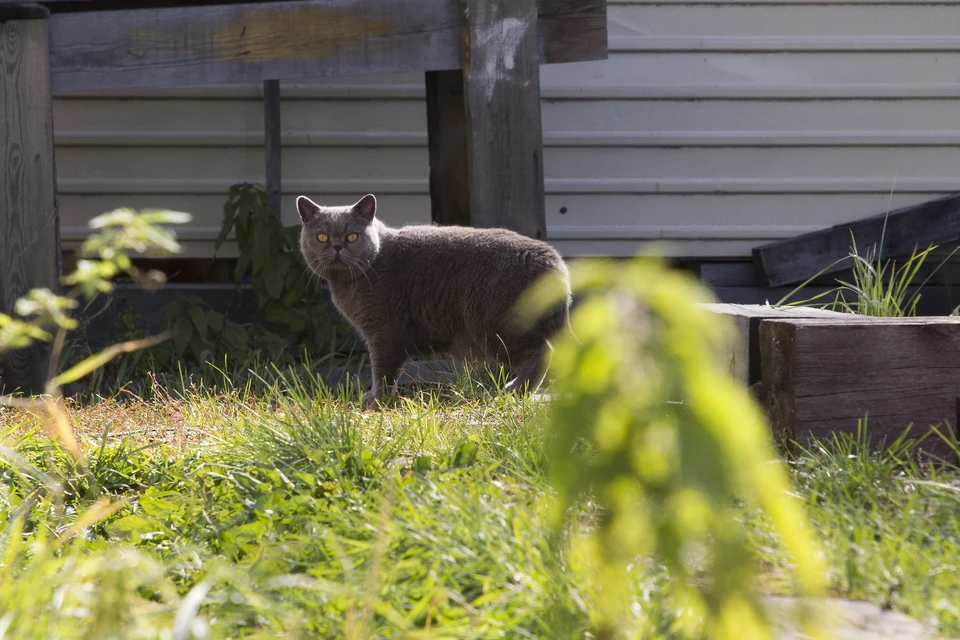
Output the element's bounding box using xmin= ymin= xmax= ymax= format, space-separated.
xmin=297 ymin=195 xmax=570 ymax=404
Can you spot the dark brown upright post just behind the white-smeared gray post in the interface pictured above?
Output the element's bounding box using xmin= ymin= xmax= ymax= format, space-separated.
xmin=426 ymin=69 xmax=470 ymax=226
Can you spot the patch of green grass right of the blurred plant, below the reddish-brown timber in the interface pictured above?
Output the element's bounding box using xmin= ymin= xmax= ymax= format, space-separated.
xmin=744 ymin=423 xmax=960 ymax=637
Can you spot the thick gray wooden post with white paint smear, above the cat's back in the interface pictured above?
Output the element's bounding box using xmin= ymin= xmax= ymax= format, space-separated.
xmin=460 ymin=0 xmax=547 ymax=239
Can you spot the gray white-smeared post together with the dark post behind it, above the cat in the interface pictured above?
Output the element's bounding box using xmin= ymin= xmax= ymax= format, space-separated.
xmin=427 ymin=0 xmax=547 ymax=239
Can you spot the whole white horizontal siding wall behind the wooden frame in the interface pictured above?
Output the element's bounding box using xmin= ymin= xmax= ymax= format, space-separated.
xmin=55 ymin=0 xmax=960 ymax=257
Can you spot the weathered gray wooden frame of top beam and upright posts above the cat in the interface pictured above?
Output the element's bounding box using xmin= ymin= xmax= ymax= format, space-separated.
xmin=0 ymin=0 xmax=607 ymax=391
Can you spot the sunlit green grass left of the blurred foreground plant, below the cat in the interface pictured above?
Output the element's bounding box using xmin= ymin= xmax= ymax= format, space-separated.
xmin=0 ymin=376 xmax=668 ymax=638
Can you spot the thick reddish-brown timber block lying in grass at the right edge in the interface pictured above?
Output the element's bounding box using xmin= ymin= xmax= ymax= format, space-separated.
xmin=760 ymin=316 xmax=960 ymax=455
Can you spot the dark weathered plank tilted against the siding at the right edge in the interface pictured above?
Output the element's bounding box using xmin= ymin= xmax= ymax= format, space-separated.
xmin=753 ymin=195 xmax=960 ymax=287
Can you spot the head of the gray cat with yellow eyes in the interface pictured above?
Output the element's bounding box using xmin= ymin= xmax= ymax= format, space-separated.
xmin=297 ymin=195 xmax=380 ymax=277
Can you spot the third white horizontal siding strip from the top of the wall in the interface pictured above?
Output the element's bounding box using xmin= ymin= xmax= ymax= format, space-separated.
xmin=55 ymin=100 xmax=960 ymax=147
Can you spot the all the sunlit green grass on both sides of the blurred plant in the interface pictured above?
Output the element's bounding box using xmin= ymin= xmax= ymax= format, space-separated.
xmin=0 ymin=381 xmax=960 ymax=638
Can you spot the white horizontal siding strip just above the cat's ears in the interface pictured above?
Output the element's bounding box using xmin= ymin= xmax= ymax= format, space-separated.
xmin=57 ymin=147 xmax=960 ymax=185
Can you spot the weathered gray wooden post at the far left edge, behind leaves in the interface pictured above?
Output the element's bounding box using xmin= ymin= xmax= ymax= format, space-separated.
xmin=0 ymin=5 xmax=60 ymax=393
